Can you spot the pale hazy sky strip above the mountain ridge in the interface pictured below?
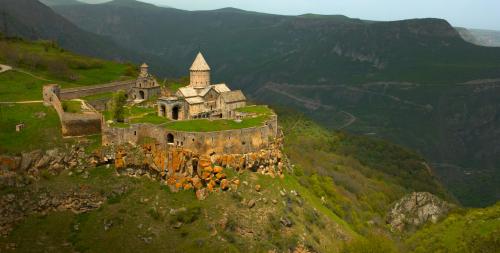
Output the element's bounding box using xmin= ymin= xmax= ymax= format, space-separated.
xmin=83 ymin=0 xmax=500 ymax=30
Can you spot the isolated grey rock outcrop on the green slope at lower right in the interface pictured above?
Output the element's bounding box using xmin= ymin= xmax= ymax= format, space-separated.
xmin=387 ymin=192 xmax=453 ymax=232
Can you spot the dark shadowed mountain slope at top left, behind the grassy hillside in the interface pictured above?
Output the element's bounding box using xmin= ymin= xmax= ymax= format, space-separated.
xmin=0 ymin=0 xmax=171 ymax=74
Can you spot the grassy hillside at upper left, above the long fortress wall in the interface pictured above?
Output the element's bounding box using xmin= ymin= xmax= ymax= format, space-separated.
xmin=0 ymin=38 xmax=136 ymax=102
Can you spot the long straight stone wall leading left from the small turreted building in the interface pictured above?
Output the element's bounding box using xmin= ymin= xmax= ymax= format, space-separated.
xmin=60 ymin=80 xmax=135 ymax=100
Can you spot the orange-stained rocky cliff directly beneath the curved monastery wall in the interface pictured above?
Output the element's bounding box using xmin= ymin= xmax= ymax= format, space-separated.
xmin=111 ymin=138 xmax=286 ymax=200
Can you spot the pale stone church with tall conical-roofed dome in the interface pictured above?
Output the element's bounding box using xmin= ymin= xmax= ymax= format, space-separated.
xmin=158 ymin=53 xmax=246 ymax=120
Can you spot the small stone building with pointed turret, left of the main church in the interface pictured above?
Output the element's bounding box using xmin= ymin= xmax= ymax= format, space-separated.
xmin=129 ymin=63 xmax=161 ymax=100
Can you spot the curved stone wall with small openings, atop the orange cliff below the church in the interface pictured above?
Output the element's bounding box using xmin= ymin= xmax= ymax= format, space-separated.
xmin=102 ymin=116 xmax=278 ymax=155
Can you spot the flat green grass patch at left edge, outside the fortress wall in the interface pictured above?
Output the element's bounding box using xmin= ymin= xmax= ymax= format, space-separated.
xmin=0 ymin=103 xmax=62 ymax=153
